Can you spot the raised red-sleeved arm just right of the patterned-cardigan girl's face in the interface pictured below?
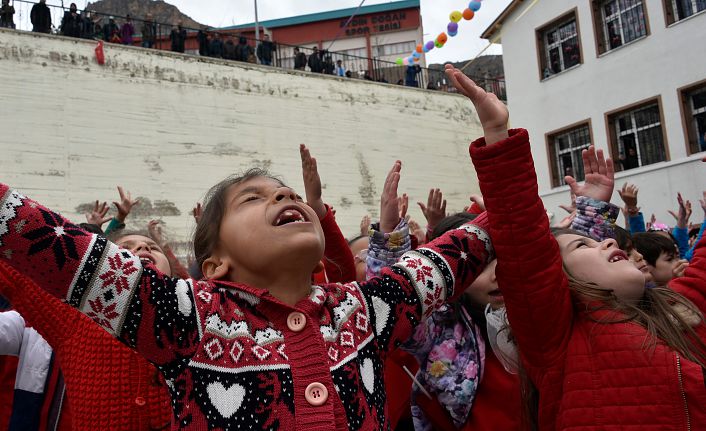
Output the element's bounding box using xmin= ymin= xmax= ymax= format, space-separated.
xmin=299 ymin=144 xmax=355 ymax=283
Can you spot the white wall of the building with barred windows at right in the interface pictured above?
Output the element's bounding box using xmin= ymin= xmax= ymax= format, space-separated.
xmin=502 ymin=0 xmax=706 ymax=223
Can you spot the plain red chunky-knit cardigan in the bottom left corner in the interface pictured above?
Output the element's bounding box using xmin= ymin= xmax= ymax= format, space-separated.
xmin=0 ymin=279 xmax=171 ymax=431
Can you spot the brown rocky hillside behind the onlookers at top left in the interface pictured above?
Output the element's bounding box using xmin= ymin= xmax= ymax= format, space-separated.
xmin=86 ymin=0 xmax=202 ymax=28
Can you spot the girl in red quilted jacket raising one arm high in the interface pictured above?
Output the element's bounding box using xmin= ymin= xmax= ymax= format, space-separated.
xmin=442 ymin=68 xmax=706 ymax=430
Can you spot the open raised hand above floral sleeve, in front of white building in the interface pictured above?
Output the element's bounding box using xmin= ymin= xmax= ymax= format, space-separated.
xmin=564 ymin=145 xmax=615 ymax=202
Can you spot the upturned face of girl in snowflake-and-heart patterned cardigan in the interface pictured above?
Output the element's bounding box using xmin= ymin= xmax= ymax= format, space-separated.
xmin=214 ymin=177 xmax=325 ymax=282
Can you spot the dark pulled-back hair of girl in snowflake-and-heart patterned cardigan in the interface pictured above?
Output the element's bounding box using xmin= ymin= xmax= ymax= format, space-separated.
xmin=194 ymin=168 xmax=285 ymax=268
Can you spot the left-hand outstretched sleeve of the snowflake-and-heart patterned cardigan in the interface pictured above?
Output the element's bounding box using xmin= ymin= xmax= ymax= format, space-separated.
xmin=0 ymin=184 xmax=199 ymax=368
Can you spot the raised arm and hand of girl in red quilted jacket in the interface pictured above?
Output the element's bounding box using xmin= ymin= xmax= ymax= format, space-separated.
xmin=446 ymin=65 xmax=573 ymax=372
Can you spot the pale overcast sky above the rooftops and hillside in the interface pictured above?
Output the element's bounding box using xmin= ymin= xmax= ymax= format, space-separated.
xmin=20 ymin=0 xmax=511 ymax=63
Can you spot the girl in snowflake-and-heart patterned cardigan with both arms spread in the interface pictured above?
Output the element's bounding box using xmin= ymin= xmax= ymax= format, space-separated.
xmin=0 ymin=144 xmax=493 ymax=430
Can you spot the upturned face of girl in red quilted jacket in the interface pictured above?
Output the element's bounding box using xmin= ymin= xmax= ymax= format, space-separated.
xmin=557 ymin=234 xmax=645 ymax=301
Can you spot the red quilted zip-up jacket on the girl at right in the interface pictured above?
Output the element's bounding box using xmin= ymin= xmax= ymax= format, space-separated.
xmin=470 ymin=130 xmax=706 ymax=431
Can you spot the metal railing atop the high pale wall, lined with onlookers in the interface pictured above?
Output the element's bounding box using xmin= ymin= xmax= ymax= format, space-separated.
xmin=2 ymin=0 xmax=506 ymax=100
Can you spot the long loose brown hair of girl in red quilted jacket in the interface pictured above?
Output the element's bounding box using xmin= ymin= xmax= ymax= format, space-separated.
xmin=519 ymin=228 xmax=706 ymax=430
